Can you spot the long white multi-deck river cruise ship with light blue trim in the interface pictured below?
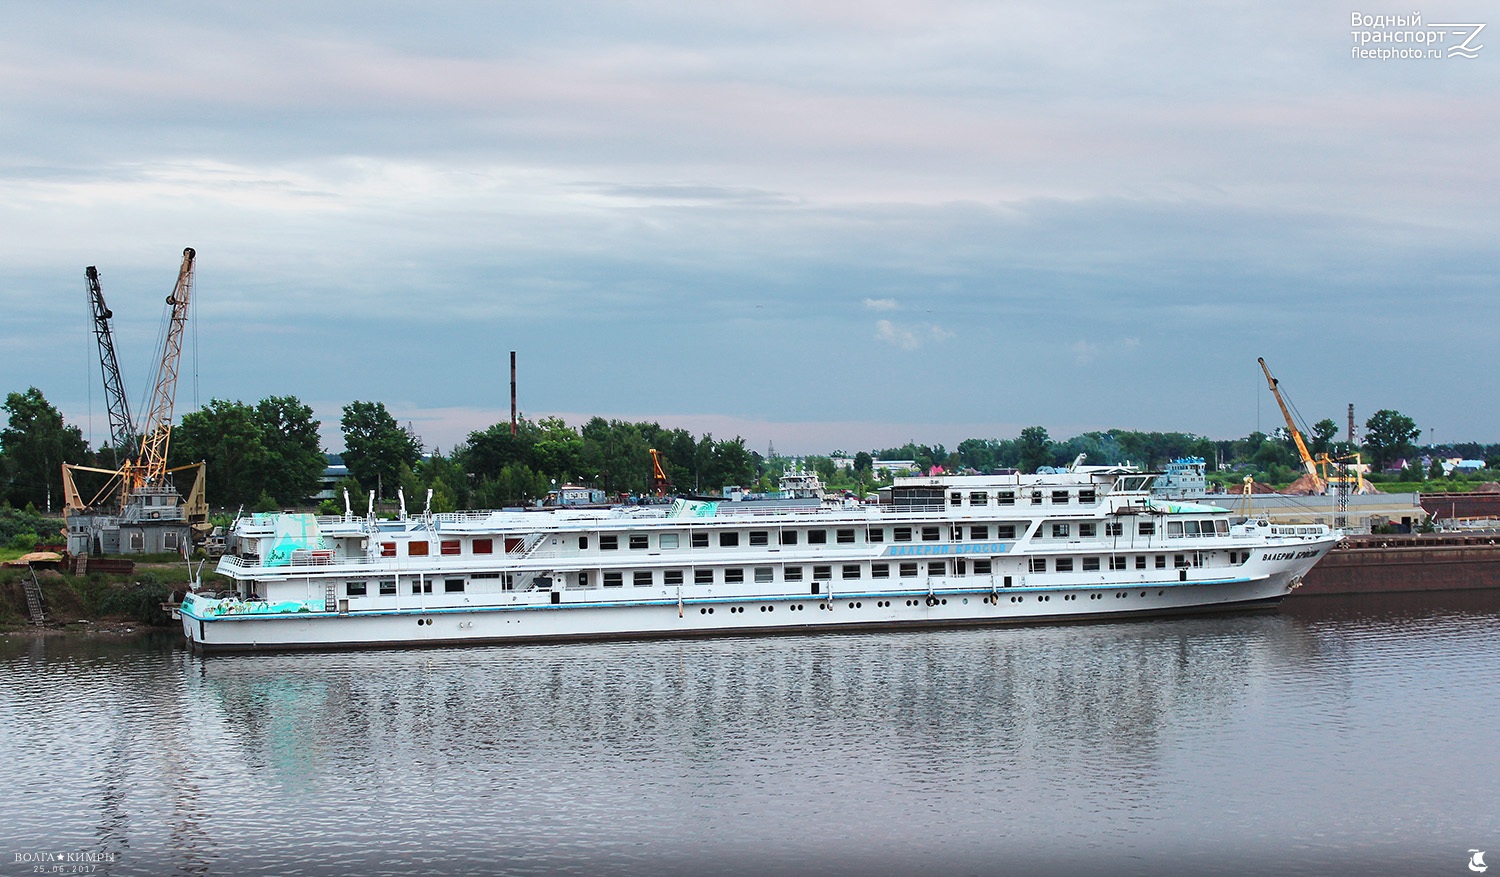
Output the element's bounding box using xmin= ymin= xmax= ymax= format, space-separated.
xmin=177 ymin=466 xmax=1341 ymax=651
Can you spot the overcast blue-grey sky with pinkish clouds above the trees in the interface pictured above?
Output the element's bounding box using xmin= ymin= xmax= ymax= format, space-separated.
xmin=0 ymin=0 xmax=1500 ymax=453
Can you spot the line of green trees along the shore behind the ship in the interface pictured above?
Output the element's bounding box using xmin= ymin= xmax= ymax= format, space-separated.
xmin=0 ymin=387 xmax=1500 ymax=511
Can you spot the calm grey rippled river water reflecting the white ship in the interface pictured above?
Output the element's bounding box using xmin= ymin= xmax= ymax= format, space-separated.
xmin=0 ymin=592 xmax=1500 ymax=874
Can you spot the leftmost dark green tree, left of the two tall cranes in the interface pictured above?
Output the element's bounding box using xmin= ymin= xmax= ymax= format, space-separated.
xmin=0 ymin=387 xmax=92 ymax=510
